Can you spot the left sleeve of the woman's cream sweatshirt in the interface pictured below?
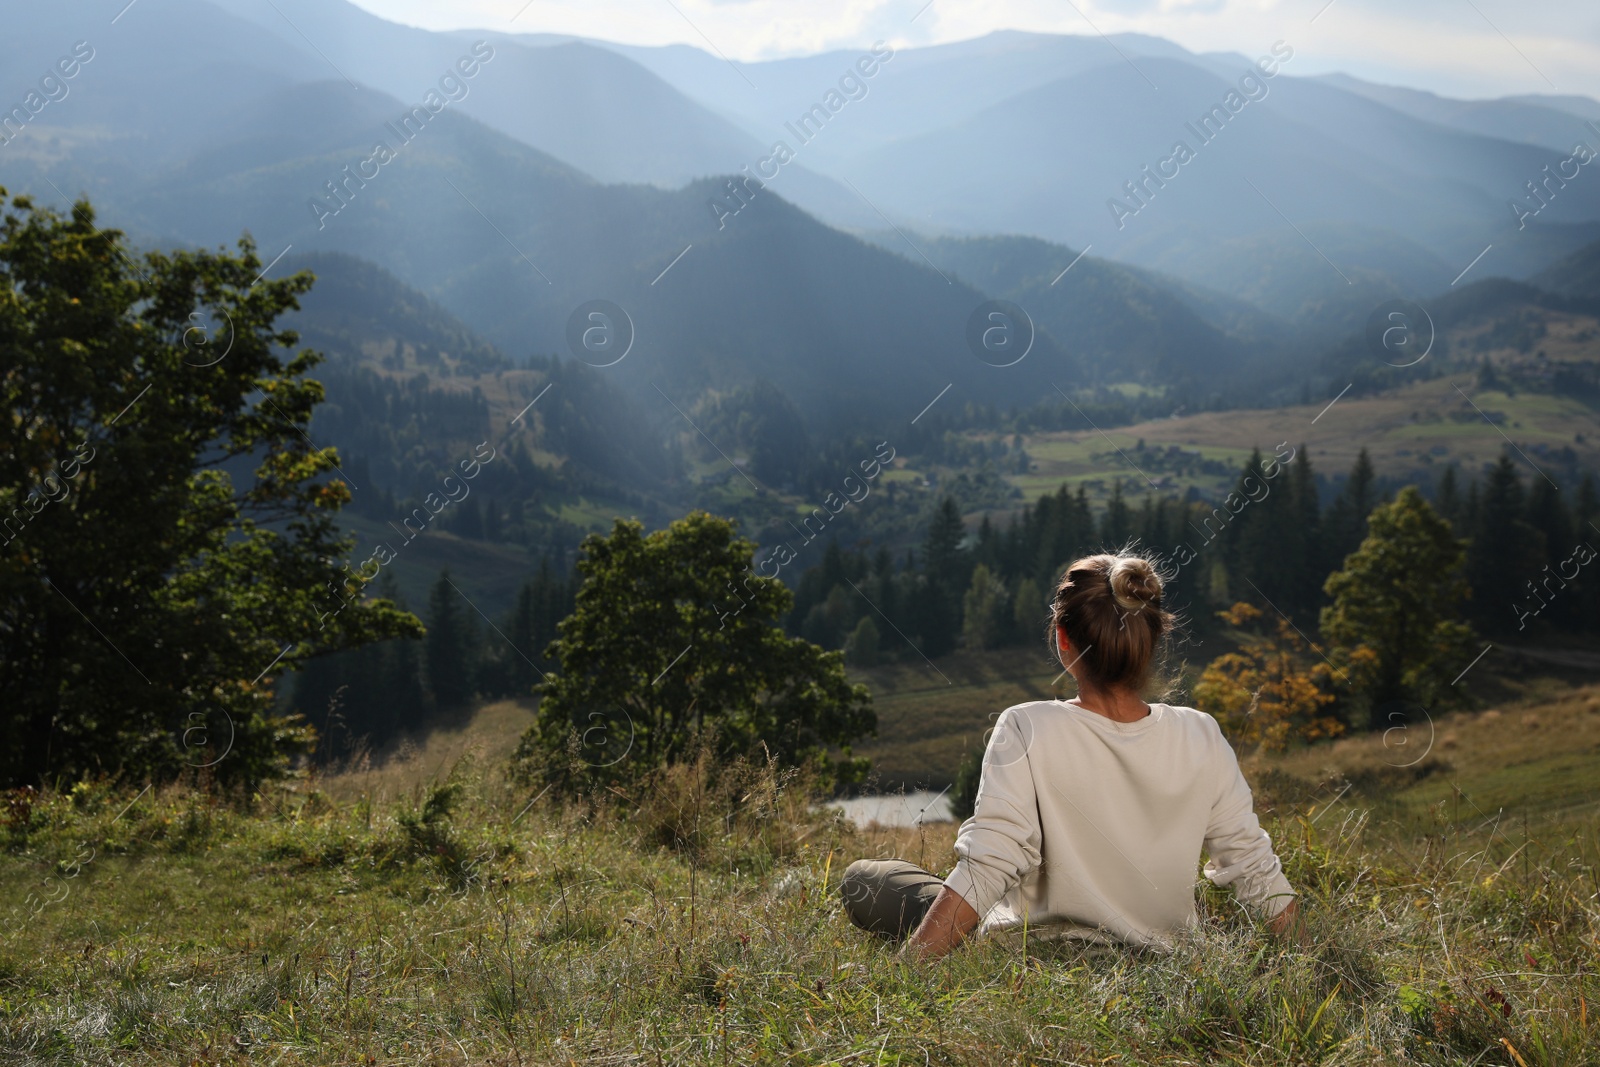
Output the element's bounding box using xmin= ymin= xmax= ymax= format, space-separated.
xmin=944 ymin=709 xmax=1042 ymax=918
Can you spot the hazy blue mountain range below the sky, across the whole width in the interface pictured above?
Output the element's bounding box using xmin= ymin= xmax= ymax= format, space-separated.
xmin=0 ymin=0 xmax=1600 ymax=426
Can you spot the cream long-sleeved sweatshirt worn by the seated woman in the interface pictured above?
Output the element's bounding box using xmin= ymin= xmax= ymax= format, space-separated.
xmin=946 ymin=701 xmax=1294 ymax=949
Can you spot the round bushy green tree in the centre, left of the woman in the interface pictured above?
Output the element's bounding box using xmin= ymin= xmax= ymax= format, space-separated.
xmin=515 ymin=512 xmax=877 ymax=787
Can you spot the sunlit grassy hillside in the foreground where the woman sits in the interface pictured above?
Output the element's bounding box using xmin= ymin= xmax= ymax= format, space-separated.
xmin=0 ymin=691 xmax=1600 ymax=1065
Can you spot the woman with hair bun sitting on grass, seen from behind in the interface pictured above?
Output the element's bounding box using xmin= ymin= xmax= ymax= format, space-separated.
xmin=842 ymin=553 xmax=1298 ymax=960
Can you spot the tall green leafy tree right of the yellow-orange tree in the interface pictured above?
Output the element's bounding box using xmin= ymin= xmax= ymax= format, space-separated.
xmin=1322 ymin=486 xmax=1472 ymax=713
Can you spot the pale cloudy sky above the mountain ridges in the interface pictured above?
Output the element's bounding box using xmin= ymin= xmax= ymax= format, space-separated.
xmin=354 ymin=0 xmax=1600 ymax=99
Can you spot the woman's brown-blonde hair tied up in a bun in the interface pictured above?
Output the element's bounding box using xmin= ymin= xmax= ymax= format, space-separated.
xmin=1050 ymin=550 xmax=1174 ymax=689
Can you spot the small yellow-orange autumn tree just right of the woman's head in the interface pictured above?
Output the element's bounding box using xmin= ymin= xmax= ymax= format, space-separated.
xmin=1195 ymin=601 xmax=1346 ymax=752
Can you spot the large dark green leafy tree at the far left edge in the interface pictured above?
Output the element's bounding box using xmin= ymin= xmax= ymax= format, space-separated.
xmin=0 ymin=190 xmax=419 ymax=787
